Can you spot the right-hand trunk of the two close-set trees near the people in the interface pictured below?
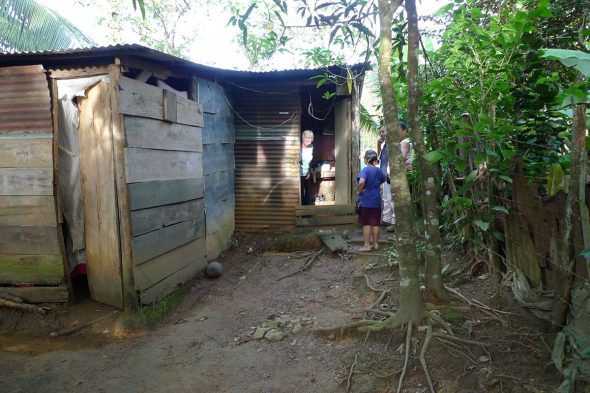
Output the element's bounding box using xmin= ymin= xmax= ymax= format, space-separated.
xmin=406 ymin=0 xmax=448 ymax=302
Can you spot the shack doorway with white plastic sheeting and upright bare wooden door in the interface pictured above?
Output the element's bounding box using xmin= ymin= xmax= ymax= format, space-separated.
xmin=56 ymin=75 xmax=123 ymax=308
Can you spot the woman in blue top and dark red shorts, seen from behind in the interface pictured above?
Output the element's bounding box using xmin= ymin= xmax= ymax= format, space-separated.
xmin=357 ymin=150 xmax=387 ymax=251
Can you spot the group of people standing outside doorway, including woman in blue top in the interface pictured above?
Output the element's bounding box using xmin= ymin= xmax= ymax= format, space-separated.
xmin=357 ymin=122 xmax=414 ymax=251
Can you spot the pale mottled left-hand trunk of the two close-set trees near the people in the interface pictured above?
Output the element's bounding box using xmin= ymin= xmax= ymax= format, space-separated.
xmin=379 ymin=0 xmax=425 ymax=324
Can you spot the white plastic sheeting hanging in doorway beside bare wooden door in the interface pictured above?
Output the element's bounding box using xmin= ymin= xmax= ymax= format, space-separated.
xmin=57 ymin=75 xmax=109 ymax=271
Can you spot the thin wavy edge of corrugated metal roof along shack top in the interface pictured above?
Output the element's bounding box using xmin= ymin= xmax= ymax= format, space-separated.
xmin=0 ymin=44 xmax=371 ymax=79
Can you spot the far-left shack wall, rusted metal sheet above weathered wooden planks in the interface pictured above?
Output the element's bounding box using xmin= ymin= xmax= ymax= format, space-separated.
xmin=0 ymin=65 xmax=68 ymax=302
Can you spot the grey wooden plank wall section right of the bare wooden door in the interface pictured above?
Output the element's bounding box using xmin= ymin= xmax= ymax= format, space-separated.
xmin=119 ymin=77 xmax=207 ymax=304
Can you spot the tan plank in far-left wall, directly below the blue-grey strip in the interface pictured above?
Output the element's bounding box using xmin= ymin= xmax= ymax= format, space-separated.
xmin=0 ymin=138 xmax=53 ymax=168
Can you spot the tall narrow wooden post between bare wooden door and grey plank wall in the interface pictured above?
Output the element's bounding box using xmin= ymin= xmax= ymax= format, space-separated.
xmin=109 ymin=59 xmax=139 ymax=310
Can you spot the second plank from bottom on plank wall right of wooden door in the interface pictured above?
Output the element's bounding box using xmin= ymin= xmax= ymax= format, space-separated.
xmin=135 ymin=236 xmax=207 ymax=291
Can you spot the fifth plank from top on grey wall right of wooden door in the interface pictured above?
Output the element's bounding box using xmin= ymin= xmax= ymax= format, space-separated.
xmin=131 ymin=199 xmax=205 ymax=236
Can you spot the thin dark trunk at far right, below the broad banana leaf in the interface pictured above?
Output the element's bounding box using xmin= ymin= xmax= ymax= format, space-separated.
xmin=551 ymin=104 xmax=587 ymax=328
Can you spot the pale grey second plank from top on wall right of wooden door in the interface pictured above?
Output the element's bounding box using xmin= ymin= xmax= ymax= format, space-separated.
xmin=125 ymin=116 xmax=203 ymax=152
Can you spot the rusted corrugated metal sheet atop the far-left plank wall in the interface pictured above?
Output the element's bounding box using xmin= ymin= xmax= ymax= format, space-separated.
xmin=0 ymin=65 xmax=53 ymax=135
